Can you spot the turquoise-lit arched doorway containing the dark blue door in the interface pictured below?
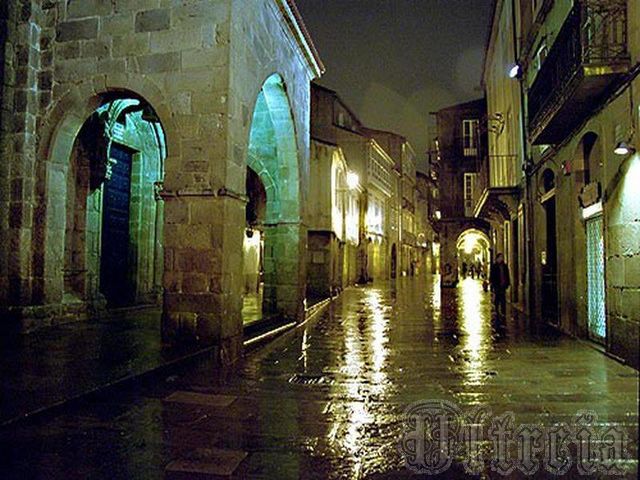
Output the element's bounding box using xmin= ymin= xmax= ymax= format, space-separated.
xmin=61 ymin=94 xmax=166 ymax=306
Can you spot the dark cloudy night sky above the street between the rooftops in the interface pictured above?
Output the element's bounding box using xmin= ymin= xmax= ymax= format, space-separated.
xmin=296 ymin=0 xmax=491 ymax=165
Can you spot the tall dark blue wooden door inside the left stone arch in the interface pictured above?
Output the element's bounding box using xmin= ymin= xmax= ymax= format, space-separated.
xmin=100 ymin=145 xmax=132 ymax=305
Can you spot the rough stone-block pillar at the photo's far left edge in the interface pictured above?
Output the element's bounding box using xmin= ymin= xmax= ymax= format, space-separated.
xmin=0 ymin=1 xmax=45 ymax=330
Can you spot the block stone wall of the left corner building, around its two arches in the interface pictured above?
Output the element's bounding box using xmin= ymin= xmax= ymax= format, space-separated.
xmin=0 ymin=0 xmax=315 ymax=358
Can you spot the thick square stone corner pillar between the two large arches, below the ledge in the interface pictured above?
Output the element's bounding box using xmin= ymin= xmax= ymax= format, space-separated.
xmin=162 ymin=191 xmax=245 ymax=363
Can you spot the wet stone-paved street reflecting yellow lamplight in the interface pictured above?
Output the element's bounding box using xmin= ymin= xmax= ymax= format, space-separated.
xmin=0 ymin=276 xmax=638 ymax=480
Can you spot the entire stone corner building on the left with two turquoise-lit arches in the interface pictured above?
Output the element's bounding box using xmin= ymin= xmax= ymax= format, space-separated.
xmin=0 ymin=0 xmax=323 ymax=361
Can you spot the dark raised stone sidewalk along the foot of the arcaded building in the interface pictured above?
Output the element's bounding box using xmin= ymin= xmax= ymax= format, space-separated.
xmin=0 ymin=300 xmax=336 ymax=426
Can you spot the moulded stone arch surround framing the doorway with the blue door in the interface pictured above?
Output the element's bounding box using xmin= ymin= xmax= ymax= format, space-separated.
xmin=32 ymin=78 xmax=176 ymax=310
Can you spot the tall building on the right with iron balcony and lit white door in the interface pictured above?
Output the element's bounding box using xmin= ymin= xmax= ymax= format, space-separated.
xmin=478 ymin=0 xmax=640 ymax=368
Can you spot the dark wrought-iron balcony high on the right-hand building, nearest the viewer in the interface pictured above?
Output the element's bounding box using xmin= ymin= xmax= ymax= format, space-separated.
xmin=528 ymin=0 xmax=629 ymax=144
